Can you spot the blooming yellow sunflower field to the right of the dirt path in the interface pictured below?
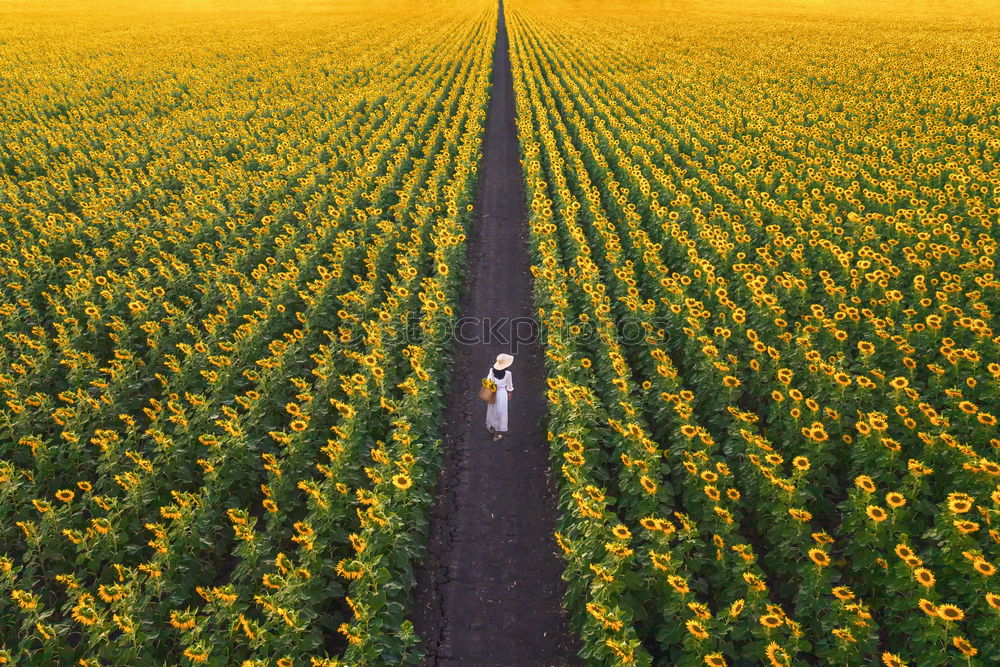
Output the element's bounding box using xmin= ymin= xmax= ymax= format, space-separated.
xmin=506 ymin=0 xmax=1000 ymax=666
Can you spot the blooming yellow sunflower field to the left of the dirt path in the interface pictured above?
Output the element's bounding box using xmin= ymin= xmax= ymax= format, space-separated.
xmin=0 ymin=0 xmax=496 ymax=667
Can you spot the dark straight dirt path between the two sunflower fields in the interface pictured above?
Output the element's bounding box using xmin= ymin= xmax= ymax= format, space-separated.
xmin=414 ymin=2 xmax=579 ymax=667
